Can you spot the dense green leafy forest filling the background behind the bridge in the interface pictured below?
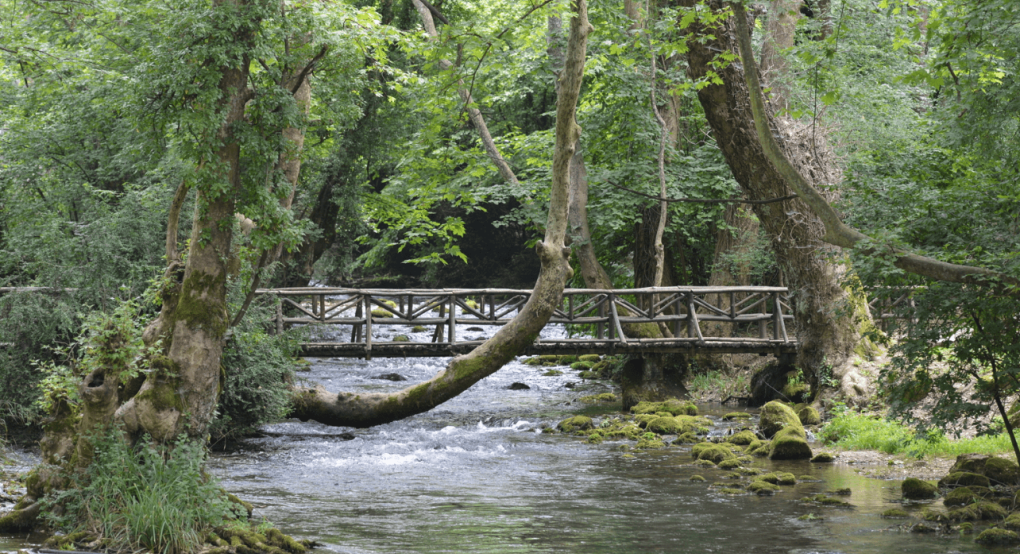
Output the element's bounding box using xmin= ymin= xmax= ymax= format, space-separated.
xmin=0 ymin=0 xmax=1020 ymax=446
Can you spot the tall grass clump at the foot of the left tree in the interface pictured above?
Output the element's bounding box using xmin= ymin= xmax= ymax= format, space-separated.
xmin=46 ymin=432 xmax=241 ymax=554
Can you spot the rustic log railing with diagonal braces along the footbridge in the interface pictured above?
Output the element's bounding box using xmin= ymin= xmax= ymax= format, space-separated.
xmin=257 ymin=287 xmax=794 ymax=345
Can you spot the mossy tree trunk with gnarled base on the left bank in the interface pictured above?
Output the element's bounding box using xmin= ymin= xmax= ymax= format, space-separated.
xmin=0 ymin=0 xmax=257 ymax=531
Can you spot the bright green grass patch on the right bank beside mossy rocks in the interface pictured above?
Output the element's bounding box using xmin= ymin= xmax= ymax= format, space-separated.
xmin=819 ymin=409 xmax=1013 ymax=458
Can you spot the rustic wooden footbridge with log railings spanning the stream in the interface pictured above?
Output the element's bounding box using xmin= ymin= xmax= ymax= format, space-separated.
xmin=257 ymin=287 xmax=797 ymax=359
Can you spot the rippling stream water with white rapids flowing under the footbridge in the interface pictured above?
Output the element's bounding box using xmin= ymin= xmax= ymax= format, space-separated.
xmin=0 ymin=318 xmax=1003 ymax=554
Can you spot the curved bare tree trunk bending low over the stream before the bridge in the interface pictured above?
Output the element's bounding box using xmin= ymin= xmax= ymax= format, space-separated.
xmin=283 ymin=0 xmax=592 ymax=426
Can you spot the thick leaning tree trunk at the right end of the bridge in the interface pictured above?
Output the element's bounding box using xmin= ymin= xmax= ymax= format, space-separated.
xmin=681 ymin=0 xmax=867 ymax=400
